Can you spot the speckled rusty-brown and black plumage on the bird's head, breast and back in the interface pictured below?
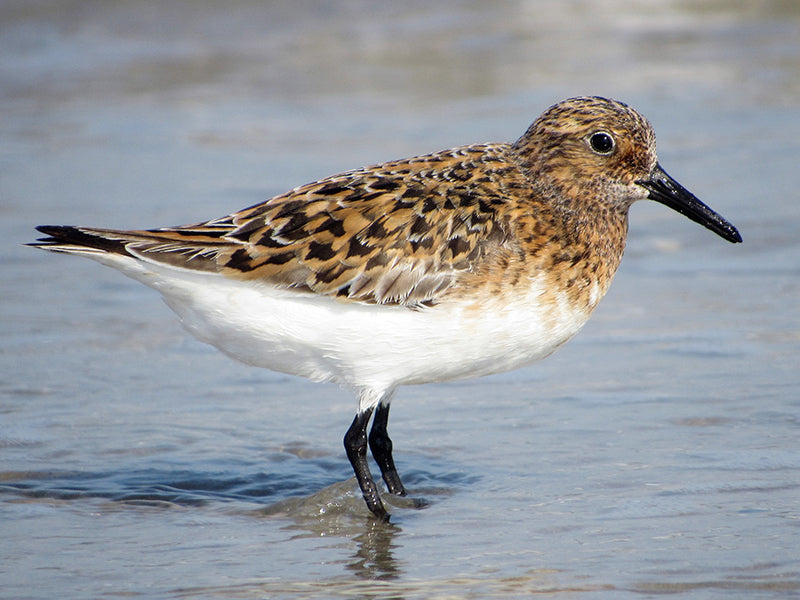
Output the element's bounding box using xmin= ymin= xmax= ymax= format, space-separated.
xmin=37 ymin=98 xmax=655 ymax=308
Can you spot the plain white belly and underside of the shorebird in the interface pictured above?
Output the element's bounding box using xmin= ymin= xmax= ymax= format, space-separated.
xmin=83 ymin=255 xmax=590 ymax=398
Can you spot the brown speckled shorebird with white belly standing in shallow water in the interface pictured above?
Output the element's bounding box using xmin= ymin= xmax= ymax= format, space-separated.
xmin=31 ymin=97 xmax=742 ymax=520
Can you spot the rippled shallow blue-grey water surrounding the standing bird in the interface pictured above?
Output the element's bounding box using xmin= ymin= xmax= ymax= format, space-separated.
xmin=0 ymin=0 xmax=800 ymax=599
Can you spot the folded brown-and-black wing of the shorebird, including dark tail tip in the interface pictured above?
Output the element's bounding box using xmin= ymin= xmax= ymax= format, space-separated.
xmin=38 ymin=144 xmax=528 ymax=306
